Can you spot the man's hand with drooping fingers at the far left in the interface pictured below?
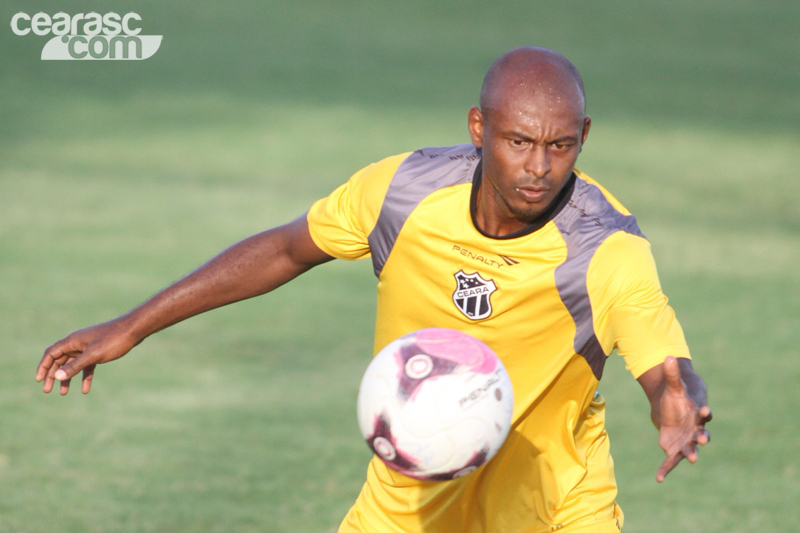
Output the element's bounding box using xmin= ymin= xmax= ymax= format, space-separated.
xmin=36 ymin=319 xmax=137 ymax=396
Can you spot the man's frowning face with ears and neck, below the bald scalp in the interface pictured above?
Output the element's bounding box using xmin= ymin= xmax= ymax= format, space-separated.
xmin=469 ymin=91 xmax=591 ymax=236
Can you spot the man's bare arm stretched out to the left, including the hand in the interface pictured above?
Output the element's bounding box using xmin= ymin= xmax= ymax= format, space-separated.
xmin=36 ymin=215 xmax=332 ymax=395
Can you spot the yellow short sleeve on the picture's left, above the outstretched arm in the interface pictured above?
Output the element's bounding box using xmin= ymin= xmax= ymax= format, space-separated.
xmin=307 ymin=154 xmax=408 ymax=260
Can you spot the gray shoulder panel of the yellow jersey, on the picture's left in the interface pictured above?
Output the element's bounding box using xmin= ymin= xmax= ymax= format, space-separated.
xmin=368 ymin=144 xmax=480 ymax=277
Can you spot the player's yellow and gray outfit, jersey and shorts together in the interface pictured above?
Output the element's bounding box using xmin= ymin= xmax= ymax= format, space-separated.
xmin=307 ymin=145 xmax=689 ymax=533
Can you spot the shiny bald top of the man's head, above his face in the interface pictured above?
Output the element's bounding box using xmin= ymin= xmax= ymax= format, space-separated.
xmin=480 ymin=47 xmax=586 ymax=116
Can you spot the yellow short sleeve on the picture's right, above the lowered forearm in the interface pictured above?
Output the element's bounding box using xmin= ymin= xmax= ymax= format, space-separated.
xmin=587 ymin=232 xmax=690 ymax=378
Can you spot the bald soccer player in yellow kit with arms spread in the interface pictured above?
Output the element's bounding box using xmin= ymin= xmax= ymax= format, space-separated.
xmin=36 ymin=48 xmax=711 ymax=533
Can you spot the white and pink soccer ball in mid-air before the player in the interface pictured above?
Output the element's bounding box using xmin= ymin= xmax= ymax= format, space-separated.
xmin=357 ymin=329 xmax=514 ymax=481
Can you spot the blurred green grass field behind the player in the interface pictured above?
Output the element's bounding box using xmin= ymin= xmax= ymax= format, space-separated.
xmin=0 ymin=0 xmax=800 ymax=533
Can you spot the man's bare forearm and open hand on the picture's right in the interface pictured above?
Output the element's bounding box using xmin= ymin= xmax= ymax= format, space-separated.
xmin=638 ymin=357 xmax=711 ymax=483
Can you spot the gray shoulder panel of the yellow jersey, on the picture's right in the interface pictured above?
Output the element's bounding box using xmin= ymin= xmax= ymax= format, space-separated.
xmin=553 ymin=178 xmax=644 ymax=380
